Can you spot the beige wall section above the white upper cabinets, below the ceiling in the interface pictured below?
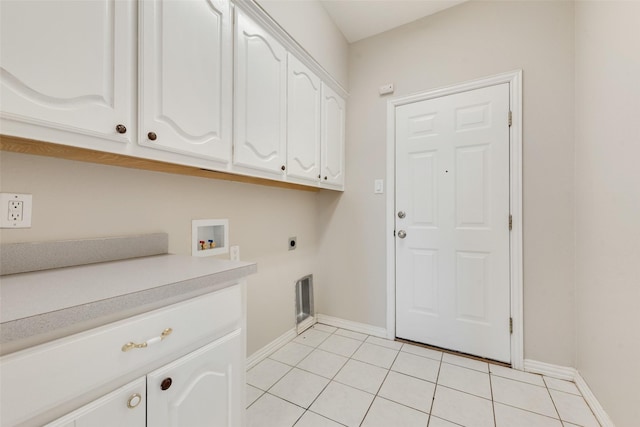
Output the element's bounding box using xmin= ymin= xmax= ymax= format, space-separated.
xmin=258 ymin=0 xmax=349 ymax=89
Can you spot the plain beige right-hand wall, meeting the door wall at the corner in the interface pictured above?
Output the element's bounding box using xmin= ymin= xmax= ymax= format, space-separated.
xmin=575 ymin=1 xmax=640 ymax=427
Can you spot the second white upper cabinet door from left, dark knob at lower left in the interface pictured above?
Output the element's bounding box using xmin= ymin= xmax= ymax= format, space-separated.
xmin=139 ymin=0 xmax=233 ymax=163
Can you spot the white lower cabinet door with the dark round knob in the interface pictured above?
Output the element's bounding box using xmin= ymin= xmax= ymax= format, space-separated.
xmin=147 ymin=329 xmax=244 ymax=427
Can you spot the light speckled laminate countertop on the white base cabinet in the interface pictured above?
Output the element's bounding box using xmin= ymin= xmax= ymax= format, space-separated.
xmin=0 ymin=255 xmax=257 ymax=354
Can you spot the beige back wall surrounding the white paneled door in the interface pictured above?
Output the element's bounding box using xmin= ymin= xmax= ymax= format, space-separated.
xmin=317 ymin=1 xmax=575 ymax=366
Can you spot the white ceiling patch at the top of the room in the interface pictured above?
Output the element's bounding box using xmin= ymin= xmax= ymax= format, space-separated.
xmin=320 ymin=0 xmax=467 ymax=43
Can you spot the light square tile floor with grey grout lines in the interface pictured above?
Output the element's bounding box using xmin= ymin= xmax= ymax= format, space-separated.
xmin=246 ymin=324 xmax=600 ymax=427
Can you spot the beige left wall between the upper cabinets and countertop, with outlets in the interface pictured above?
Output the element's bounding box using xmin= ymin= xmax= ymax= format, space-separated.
xmin=0 ymin=152 xmax=318 ymax=354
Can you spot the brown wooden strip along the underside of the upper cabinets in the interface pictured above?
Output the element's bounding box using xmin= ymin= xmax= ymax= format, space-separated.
xmin=0 ymin=135 xmax=320 ymax=192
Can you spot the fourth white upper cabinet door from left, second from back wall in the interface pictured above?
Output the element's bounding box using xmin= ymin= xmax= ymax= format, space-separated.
xmin=287 ymin=53 xmax=322 ymax=183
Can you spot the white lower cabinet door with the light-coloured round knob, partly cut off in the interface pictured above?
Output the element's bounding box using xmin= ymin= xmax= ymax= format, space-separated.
xmin=45 ymin=378 xmax=146 ymax=427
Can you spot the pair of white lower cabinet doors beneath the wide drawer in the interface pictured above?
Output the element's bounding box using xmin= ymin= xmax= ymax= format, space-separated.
xmin=45 ymin=329 xmax=244 ymax=427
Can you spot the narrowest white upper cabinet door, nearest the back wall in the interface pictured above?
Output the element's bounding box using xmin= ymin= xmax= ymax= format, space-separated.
xmin=321 ymin=83 xmax=345 ymax=189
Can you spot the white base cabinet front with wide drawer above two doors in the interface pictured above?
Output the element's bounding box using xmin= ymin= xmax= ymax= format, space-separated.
xmin=0 ymin=281 xmax=246 ymax=427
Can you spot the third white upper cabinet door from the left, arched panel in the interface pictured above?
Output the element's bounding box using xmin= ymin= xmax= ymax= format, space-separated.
xmin=234 ymin=9 xmax=287 ymax=175
